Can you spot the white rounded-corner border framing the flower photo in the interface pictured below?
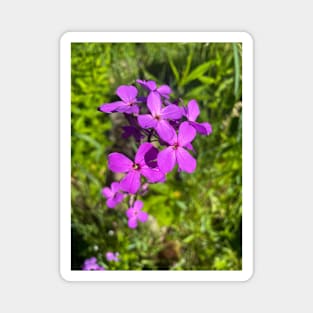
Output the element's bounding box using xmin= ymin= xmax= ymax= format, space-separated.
xmin=60 ymin=32 xmax=254 ymax=281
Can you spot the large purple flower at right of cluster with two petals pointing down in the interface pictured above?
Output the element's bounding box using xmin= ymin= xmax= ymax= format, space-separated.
xmin=158 ymin=122 xmax=197 ymax=173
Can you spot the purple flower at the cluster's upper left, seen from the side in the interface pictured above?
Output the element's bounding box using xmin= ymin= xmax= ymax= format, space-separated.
xmin=98 ymin=85 xmax=139 ymax=114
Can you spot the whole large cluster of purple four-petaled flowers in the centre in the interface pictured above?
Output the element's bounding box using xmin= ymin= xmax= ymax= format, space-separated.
xmin=98 ymin=80 xmax=212 ymax=228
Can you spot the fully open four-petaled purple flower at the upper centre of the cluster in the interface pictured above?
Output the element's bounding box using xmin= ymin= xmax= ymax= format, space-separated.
xmin=138 ymin=93 xmax=183 ymax=141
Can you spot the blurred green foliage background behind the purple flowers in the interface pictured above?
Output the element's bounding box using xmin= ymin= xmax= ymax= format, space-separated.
xmin=71 ymin=43 xmax=242 ymax=270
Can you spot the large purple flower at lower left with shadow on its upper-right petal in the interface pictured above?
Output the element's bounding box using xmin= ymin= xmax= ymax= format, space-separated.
xmin=108 ymin=142 xmax=165 ymax=194
